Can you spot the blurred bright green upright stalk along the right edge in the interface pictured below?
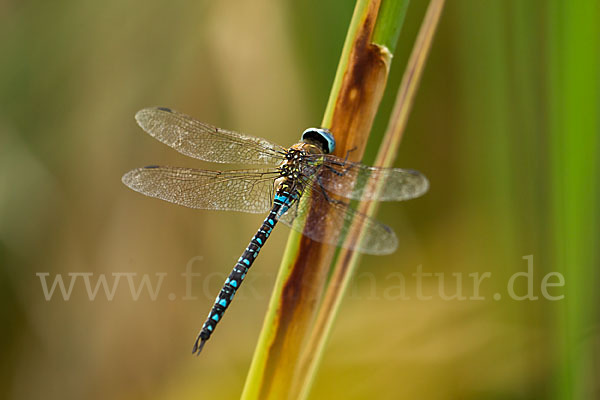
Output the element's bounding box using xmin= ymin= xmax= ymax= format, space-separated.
xmin=547 ymin=0 xmax=600 ymax=399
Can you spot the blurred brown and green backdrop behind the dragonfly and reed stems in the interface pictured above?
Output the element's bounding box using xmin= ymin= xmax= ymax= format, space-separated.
xmin=0 ymin=0 xmax=600 ymax=399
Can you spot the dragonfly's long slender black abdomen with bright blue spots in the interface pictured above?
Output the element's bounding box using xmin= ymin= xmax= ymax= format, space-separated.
xmin=192 ymin=189 xmax=298 ymax=354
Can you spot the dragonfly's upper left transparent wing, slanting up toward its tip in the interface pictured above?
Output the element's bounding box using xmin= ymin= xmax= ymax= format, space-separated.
xmin=135 ymin=107 xmax=285 ymax=165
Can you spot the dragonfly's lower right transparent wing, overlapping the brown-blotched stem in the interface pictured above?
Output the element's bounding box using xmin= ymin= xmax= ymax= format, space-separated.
xmin=279 ymin=181 xmax=398 ymax=255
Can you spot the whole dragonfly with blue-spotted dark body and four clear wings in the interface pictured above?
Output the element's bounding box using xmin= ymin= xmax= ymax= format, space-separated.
xmin=122 ymin=107 xmax=429 ymax=354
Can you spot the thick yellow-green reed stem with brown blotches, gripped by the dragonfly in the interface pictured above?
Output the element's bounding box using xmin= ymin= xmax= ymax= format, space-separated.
xmin=242 ymin=0 xmax=396 ymax=400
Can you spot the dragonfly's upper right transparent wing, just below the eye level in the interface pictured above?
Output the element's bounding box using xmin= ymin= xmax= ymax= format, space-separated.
xmin=318 ymin=154 xmax=429 ymax=201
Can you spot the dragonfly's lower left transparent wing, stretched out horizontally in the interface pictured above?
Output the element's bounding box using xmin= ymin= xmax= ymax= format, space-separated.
xmin=122 ymin=166 xmax=278 ymax=213
